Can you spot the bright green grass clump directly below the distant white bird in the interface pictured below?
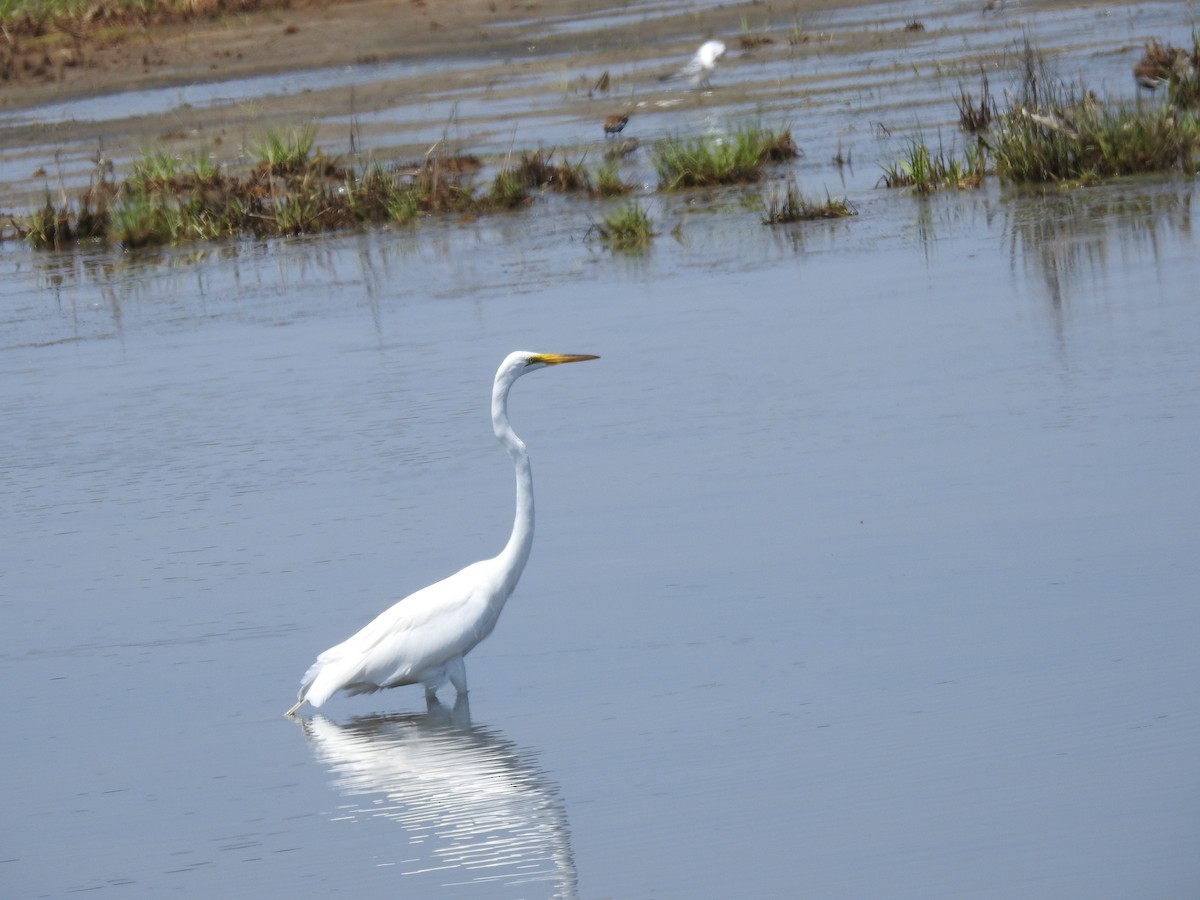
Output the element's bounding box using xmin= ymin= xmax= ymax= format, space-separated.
xmin=653 ymin=126 xmax=799 ymax=191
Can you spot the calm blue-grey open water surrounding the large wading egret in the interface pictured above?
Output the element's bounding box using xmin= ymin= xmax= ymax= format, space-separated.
xmin=0 ymin=1 xmax=1200 ymax=900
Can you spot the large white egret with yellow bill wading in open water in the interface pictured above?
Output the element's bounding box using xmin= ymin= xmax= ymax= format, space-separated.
xmin=286 ymin=350 xmax=599 ymax=715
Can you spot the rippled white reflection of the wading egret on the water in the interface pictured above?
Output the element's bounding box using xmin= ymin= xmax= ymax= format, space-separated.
xmin=301 ymin=696 xmax=576 ymax=898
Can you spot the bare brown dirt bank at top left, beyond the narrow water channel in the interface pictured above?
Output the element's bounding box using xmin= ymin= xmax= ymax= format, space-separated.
xmin=0 ymin=0 xmax=883 ymax=109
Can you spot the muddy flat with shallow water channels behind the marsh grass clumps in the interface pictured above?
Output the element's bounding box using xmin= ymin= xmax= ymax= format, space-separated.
xmin=0 ymin=0 xmax=1176 ymax=217
